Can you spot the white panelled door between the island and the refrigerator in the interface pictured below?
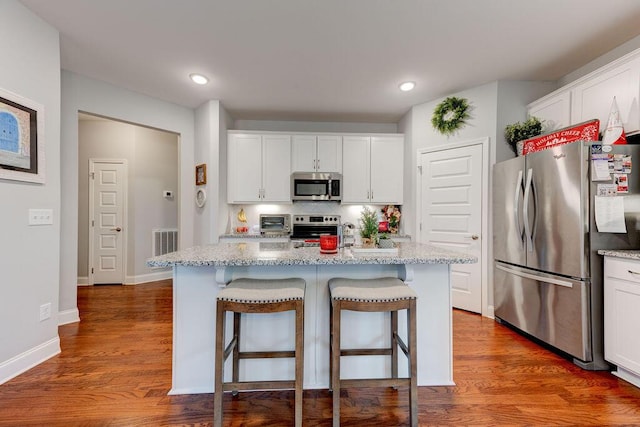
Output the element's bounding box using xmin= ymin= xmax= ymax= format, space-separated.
xmin=419 ymin=143 xmax=486 ymax=313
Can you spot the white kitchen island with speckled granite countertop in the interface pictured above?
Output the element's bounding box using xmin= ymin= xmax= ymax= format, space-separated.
xmin=148 ymin=242 xmax=477 ymax=394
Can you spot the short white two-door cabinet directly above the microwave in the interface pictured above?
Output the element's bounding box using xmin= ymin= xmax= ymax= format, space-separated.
xmin=291 ymin=135 xmax=342 ymax=172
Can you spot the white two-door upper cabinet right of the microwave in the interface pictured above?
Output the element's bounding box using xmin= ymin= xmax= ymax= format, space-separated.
xmin=342 ymin=135 xmax=404 ymax=205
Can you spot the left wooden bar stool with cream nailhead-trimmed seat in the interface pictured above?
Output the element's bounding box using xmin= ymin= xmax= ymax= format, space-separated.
xmin=213 ymin=278 xmax=305 ymax=427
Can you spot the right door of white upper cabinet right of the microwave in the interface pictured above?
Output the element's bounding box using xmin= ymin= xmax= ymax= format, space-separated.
xmin=370 ymin=136 xmax=404 ymax=205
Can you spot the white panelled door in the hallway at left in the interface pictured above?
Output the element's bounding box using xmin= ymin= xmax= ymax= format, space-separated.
xmin=89 ymin=159 xmax=127 ymax=284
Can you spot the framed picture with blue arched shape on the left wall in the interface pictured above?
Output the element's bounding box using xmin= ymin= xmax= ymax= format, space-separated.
xmin=0 ymin=89 xmax=45 ymax=184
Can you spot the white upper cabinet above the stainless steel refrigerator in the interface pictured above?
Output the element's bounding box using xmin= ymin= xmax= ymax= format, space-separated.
xmin=527 ymin=50 xmax=640 ymax=137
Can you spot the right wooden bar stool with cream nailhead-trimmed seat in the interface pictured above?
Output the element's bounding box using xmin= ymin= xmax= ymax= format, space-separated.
xmin=329 ymin=277 xmax=418 ymax=427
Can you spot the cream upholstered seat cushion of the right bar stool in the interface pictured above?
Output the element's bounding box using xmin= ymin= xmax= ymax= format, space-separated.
xmin=329 ymin=277 xmax=418 ymax=302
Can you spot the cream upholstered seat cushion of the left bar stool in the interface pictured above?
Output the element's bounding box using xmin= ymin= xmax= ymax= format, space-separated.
xmin=218 ymin=278 xmax=306 ymax=304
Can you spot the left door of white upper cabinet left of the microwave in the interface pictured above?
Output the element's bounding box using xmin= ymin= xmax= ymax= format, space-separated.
xmin=227 ymin=134 xmax=262 ymax=203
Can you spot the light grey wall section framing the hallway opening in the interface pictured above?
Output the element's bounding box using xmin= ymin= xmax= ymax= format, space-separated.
xmin=60 ymin=71 xmax=195 ymax=321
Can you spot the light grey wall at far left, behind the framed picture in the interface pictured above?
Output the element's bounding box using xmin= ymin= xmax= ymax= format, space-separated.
xmin=0 ymin=0 xmax=61 ymax=383
